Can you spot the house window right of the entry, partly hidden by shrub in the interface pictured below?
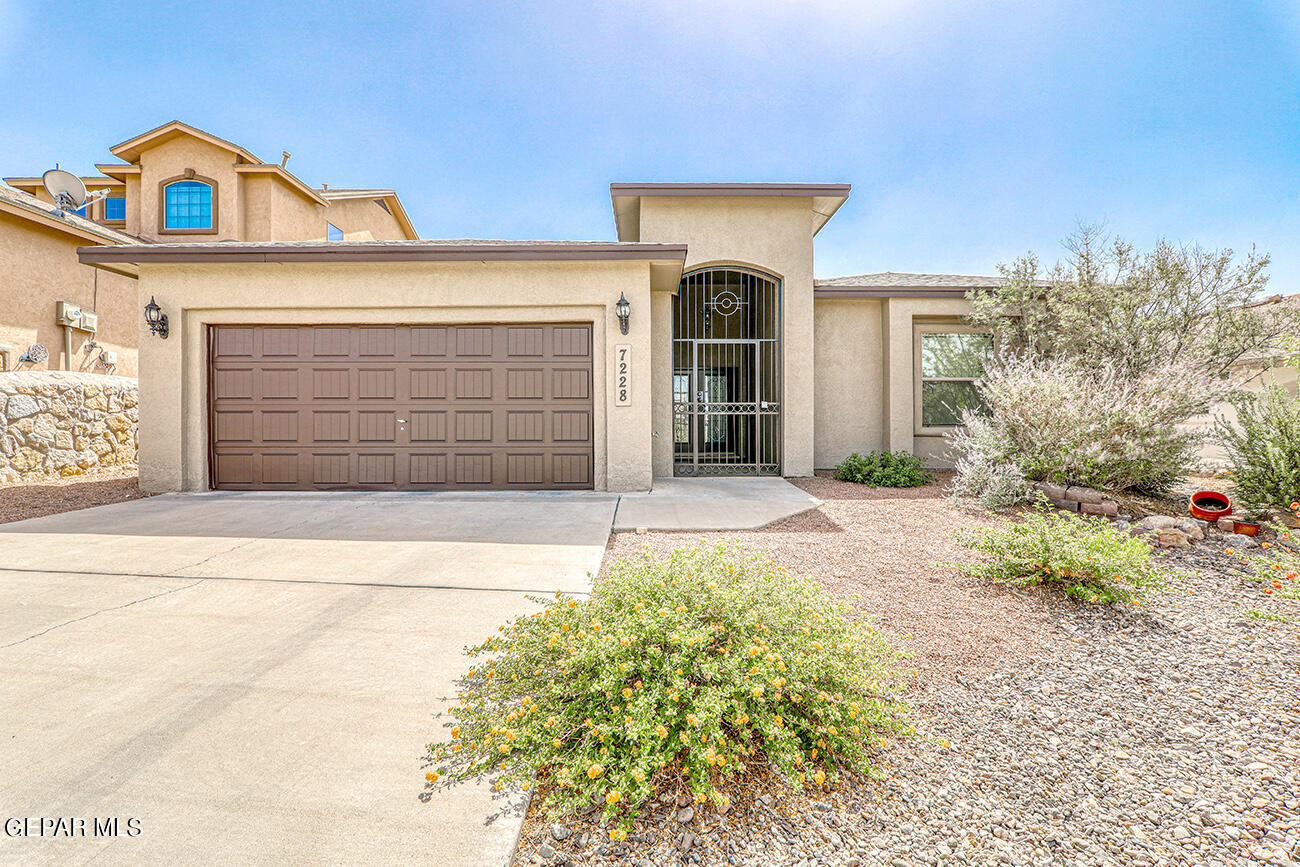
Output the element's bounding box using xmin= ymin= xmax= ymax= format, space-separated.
xmin=917 ymin=325 xmax=993 ymax=429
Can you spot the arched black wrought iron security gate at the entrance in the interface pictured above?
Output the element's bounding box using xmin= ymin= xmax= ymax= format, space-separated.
xmin=672 ymin=268 xmax=781 ymax=476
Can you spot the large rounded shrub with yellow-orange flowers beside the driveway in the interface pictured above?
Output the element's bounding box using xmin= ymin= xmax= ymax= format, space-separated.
xmin=429 ymin=545 xmax=907 ymax=840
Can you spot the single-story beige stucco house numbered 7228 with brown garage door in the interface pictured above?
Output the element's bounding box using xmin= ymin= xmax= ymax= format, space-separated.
xmin=79 ymin=183 xmax=998 ymax=491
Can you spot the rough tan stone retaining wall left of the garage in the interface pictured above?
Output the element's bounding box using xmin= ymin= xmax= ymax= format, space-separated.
xmin=0 ymin=370 xmax=139 ymax=485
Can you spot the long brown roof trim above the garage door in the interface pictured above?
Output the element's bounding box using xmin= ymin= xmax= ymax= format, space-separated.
xmin=77 ymin=242 xmax=686 ymax=265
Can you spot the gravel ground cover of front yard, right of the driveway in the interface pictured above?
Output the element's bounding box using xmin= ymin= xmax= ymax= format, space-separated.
xmin=506 ymin=478 xmax=1300 ymax=867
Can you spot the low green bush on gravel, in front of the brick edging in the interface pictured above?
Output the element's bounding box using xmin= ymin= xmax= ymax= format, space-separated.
xmin=959 ymin=512 xmax=1164 ymax=604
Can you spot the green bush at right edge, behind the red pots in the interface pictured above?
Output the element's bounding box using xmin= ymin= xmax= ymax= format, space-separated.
xmin=1214 ymin=385 xmax=1300 ymax=515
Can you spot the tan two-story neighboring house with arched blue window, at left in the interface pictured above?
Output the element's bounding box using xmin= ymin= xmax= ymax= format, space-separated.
xmin=0 ymin=121 xmax=419 ymax=376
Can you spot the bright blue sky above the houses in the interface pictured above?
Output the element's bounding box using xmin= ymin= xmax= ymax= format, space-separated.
xmin=0 ymin=0 xmax=1300 ymax=292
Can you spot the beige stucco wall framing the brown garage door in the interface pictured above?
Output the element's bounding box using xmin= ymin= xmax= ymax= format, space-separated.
xmin=140 ymin=261 xmax=651 ymax=491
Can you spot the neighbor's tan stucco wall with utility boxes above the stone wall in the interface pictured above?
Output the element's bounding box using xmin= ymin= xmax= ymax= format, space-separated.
xmin=0 ymin=213 xmax=138 ymax=376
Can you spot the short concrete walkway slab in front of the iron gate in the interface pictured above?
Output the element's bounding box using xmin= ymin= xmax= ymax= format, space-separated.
xmin=614 ymin=476 xmax=822 ymax=532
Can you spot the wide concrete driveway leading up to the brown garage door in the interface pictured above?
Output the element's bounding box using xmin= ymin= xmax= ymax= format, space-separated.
xmin=0 ymin=493 xmax=618 ymax=864
